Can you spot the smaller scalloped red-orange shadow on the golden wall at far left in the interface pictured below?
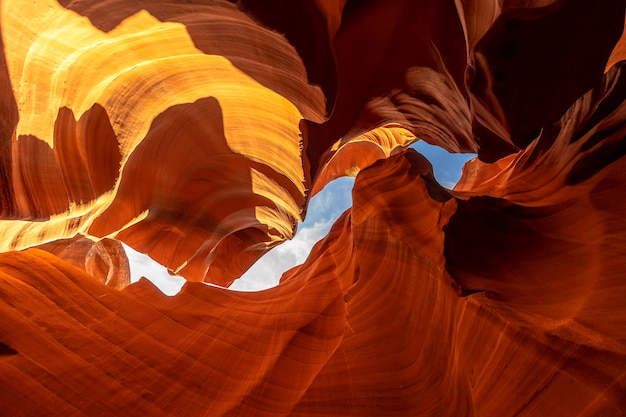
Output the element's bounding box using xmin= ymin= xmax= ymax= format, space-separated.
xmin=13 ymin=103 xmax=122 ymax=220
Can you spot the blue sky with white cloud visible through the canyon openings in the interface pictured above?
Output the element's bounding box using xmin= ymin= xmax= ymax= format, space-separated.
xmin=125 ymin=141 xmax=475 ymax=295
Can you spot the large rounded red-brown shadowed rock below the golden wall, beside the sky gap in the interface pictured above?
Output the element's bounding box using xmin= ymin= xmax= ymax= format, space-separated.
xmin=89 ymin=97 xmax=290 ymax=286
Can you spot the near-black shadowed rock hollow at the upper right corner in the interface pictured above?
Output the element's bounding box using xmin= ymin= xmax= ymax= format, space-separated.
xmin=470 ymin=0 xmax=624 ymax=148
